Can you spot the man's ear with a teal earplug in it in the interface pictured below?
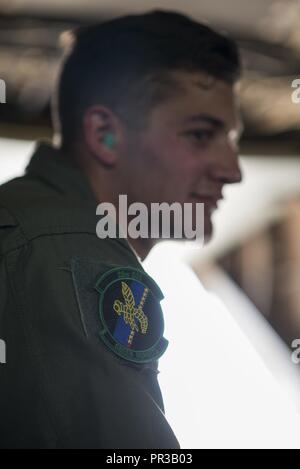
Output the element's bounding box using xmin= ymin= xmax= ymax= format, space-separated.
xmin=83 ymin=106 xmax=121 ymax=166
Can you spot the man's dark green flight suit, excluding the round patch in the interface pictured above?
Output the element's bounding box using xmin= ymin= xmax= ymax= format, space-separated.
xmin=0 ymin=144 xmax=179 ymax=449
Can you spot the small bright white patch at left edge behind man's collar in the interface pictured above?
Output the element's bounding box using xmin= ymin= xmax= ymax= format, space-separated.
xmin=0 ymin=138 xmax=34 ymax=184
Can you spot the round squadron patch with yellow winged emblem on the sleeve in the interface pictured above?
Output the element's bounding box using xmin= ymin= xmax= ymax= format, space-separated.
xmin=96 ymin=267 xmax=168 ymax=363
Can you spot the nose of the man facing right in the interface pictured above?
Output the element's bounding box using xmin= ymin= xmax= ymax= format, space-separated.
xmin=212 ymin=147 xmax=243 ymax=184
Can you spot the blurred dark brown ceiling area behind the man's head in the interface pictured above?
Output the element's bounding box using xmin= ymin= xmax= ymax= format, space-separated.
xmin=0 ymin=0 xmax=300 ymax=156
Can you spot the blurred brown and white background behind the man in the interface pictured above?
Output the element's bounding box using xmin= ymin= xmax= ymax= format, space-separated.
xmin=0 ymin=0 xmax=300 ymax=448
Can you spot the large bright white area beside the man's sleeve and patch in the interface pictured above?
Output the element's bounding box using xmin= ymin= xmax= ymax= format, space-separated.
xmin=144 ymin=245 xmax=300 ymax=449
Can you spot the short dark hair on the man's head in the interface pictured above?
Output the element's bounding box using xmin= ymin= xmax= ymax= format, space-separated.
xmin=53 ymin=10 xmax=241 ymax=145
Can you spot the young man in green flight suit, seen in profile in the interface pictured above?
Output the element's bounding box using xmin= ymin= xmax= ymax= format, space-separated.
xmin=0 ymin=11 xmax=241 ymax=448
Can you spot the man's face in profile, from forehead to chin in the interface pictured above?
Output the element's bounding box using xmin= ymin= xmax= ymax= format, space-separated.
xmin=126 ymin=72 xmax=241 ymax=240
